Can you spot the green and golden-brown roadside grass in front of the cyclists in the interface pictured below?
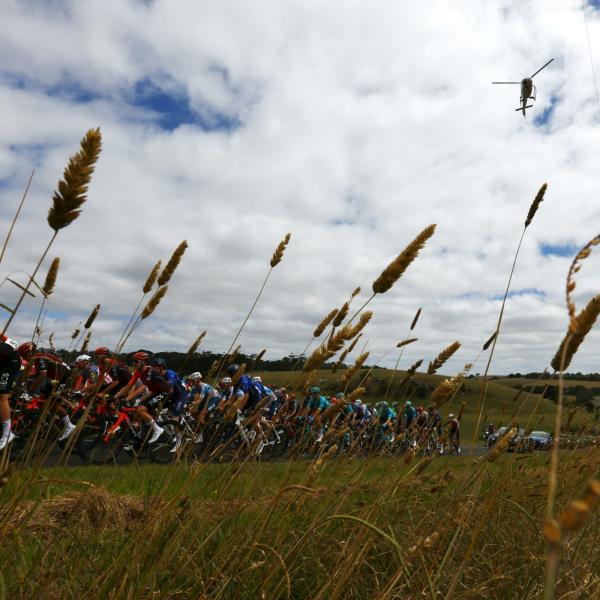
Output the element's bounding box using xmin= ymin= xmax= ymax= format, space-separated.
xmin=0 ymin=450 xmax=600 ymax=598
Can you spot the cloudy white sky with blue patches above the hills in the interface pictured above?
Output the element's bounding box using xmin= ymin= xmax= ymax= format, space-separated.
xmin=0 ymin=0 xmax=600 ymax=374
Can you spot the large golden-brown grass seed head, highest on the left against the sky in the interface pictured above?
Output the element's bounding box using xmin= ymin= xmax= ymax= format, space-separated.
xmin=48 ymin=128 xmax=102 ymax=231
